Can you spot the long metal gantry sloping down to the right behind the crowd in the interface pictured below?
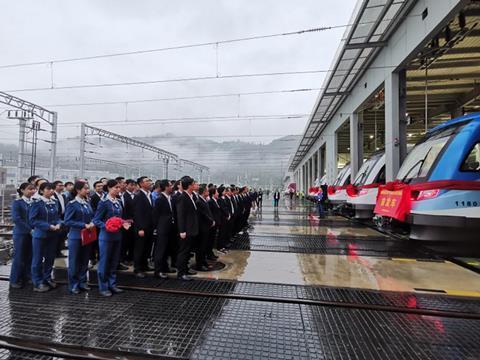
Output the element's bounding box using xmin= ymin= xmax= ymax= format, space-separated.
xmin=80 ymin=123 xmax=209 ymax=179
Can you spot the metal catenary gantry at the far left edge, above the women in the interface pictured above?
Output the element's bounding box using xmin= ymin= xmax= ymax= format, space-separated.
xmin=0 ymin=91 xmax=58 ymax=182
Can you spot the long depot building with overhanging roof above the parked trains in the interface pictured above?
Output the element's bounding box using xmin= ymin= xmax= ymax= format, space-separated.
xmin=289 ymin=0 xmax=480 ymax=192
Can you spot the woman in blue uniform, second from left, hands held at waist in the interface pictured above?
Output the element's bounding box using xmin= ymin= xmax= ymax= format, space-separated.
xmin=28 ymin=182 xmax=61 ymax=292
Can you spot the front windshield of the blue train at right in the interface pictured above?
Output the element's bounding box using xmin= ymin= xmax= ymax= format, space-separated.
xmin=397 ymin=124 xmax=464 ymax=184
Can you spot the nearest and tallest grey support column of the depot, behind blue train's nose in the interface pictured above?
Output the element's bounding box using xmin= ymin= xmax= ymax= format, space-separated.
xmin=385 ymin=73 xmax=400 ymax=181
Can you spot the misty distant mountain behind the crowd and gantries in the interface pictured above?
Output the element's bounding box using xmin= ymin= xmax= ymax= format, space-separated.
xmin=0 ymin=134 xmax=299 ymax=187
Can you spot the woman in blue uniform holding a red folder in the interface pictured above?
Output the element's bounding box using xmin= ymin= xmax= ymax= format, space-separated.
xmin=65 ymin=181 xmax=95 ymax=294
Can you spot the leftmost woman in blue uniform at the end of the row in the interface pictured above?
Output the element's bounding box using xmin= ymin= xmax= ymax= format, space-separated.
xmin=10 ymin=183 xmax=36 ymax=289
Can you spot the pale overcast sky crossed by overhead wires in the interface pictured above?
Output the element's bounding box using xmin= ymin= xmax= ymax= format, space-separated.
xmin=0 ymin=0 xmax=356 ymax=146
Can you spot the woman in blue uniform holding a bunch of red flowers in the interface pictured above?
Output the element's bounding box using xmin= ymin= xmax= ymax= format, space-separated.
xmin=93 ymin=180 xmax=130 ymax=296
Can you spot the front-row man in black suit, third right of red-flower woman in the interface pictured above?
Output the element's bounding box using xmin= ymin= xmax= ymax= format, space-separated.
xmin=176 ymin=176 xmax=198 ymax=281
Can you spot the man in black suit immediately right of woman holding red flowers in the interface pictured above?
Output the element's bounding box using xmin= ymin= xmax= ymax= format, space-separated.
xmin=133 ymin=176 xmax=154 ymax=278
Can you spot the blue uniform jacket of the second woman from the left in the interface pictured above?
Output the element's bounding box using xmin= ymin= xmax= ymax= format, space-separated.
xmin=28 ymin=200 xmax=61 ymax=238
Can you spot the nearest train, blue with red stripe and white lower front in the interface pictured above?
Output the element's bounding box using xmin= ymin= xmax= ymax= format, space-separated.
xmin=397 ymin=113 xmax=480 ymax=241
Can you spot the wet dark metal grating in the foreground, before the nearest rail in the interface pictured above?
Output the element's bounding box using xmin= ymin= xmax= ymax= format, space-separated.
xmin=0 ymin=282 xmax=480 ymax=359
